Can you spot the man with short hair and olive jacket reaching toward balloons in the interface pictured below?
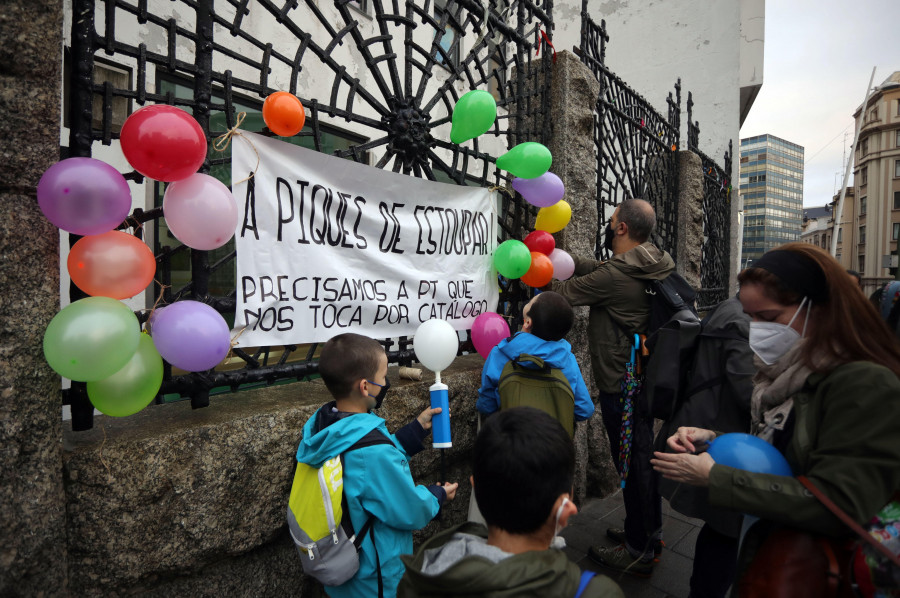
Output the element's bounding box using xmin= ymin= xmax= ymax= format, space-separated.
xmin=550 ymin=199 xmax=675 ymax=577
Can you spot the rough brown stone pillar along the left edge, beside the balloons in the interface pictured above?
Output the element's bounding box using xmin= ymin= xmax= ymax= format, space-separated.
xmin=0 ymin=0 xmax=66 ymax=596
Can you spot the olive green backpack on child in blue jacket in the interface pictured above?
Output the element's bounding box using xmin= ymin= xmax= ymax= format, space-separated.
xmin=497 ymin=353 xmax=575 ymax=437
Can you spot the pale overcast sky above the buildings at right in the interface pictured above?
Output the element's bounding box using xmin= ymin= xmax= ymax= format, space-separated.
xmin=735 ymin=0 xmax=900 ymax=206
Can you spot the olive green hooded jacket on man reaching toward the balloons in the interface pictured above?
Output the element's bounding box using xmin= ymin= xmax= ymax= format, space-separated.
xmin=551 ymin=241 xmax=675 ymax=393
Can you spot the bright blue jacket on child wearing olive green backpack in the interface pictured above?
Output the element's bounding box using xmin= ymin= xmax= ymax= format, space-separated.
xmin=475 ymin=332 xmax=594 ymax=421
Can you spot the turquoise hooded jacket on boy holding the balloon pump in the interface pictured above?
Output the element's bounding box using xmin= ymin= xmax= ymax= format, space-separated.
xmin=297 ymin=402 xmax=440 ymax=598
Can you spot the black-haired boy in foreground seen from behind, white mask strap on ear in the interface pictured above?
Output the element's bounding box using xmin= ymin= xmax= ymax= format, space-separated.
xmin=397 ymin=407 xmax=624 ymax=598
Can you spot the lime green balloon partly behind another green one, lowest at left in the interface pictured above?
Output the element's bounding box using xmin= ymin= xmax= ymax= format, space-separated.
xmin=87 ymin=334 xmax=163 ymax=417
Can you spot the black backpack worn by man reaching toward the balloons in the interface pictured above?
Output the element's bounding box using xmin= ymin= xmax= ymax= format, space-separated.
xmin=640 ymin=272 xmax=701 ymax=420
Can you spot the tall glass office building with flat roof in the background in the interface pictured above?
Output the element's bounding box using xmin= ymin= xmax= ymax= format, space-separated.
xmin=741 ymin=135 xmax=803 ymax=268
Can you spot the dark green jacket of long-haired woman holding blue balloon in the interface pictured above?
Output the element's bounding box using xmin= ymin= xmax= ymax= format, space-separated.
xmin=709 ymin=362 xmax=900 ymax=584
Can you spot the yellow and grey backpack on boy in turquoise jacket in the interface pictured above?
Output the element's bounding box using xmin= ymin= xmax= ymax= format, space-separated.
xmin=287 ymin=430 xmax=393 ymax=586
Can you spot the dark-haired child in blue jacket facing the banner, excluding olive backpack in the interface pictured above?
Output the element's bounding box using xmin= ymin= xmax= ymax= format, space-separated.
xmin=475 ymin=291 xmax=594 ymax=421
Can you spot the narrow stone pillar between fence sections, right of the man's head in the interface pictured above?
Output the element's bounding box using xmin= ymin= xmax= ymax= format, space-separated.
xmin=677 ymin=151 xmax=703 ymax=290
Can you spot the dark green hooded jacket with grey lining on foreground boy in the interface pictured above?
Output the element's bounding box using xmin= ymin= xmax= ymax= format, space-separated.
xmin=397 ymin=523 xmax=625 ymax=598
